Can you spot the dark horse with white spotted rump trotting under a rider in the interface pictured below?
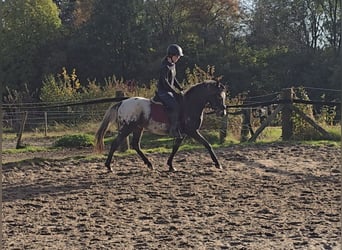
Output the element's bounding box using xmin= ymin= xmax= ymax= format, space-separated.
xmin=95 ymin=80 xmax=226 ymax=172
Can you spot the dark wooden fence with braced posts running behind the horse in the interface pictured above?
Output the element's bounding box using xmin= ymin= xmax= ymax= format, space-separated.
xmin=2 ymin=88 xmax=341 ymax=148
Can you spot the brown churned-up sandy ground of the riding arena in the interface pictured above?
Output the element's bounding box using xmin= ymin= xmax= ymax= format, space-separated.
xmin=2 ymin=144 xmax=341 ymax=250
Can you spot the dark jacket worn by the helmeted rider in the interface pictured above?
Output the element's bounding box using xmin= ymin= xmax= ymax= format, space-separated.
xmin=157 ymin=57 xmax=183 ymax=93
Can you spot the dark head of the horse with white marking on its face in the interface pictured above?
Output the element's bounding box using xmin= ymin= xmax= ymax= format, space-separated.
xmin=208 ymin=80 xmax=227 ymax=116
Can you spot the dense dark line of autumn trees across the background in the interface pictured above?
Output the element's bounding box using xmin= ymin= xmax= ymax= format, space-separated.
xmin=0 ymin=0 xmax=341 ymax=99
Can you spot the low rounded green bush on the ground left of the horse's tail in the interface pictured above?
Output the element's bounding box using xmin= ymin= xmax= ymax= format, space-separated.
xmin=54 ymin=134 xmax=94 ymax=148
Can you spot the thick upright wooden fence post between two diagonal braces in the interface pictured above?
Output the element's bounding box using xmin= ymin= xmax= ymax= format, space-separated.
xmin=281 ymin=88 xmax=294 ymax=141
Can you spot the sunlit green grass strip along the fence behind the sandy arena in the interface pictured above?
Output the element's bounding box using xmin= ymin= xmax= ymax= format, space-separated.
xmin=2 ymin=124 xmax=341 ymax=155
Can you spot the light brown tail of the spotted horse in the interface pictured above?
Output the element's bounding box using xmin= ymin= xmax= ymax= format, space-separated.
xmin=94 ymin=102 xmax=121 ymax=153
